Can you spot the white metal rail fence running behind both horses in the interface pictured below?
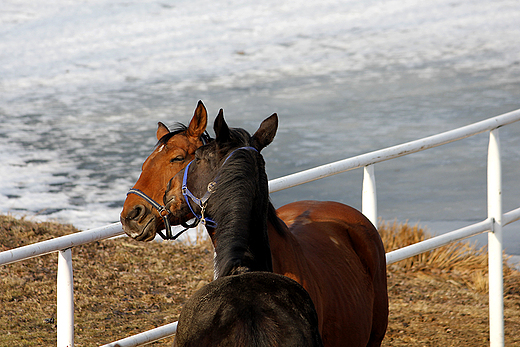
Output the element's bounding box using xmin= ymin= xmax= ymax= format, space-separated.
xmin=0 ymin=110 xmax=520 ymax=347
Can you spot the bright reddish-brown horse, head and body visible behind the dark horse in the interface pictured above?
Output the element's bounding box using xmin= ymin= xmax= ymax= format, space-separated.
xmin=121 ymin=102 xmax=388 ymax=346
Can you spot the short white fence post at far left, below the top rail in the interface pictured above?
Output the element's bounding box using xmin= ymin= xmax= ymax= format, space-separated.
xmin=56 ymin=248 xmax=74 ymax=347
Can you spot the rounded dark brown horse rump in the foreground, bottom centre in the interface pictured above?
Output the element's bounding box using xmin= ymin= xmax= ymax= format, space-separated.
xmin=173 ymin=272 xmax=323 ymax=347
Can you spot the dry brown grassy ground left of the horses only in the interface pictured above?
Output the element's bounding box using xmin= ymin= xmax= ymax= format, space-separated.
xmin=0 ymin=216 xmax=213 ymax=346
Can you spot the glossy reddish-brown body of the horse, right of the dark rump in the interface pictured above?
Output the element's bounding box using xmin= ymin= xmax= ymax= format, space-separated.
xmin=273 ymin=201 xmax=388 ymax=346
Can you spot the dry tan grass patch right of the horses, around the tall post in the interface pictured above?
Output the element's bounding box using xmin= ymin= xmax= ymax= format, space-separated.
xmin=379 ymin=222 xmax=520 ymax=346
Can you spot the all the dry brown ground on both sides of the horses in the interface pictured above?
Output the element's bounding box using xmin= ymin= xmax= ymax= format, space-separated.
xmin=0 ymin=216 xmax=520 ymax=347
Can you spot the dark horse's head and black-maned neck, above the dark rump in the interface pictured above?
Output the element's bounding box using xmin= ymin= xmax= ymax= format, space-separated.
xmin=164 ymin=110 xmax=278 ymax=276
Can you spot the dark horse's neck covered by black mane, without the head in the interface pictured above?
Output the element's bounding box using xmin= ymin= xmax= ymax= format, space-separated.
xmin=208 ymin=150 xmax=273 ymax=277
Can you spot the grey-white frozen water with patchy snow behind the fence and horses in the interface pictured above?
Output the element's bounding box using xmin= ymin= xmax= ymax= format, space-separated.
xmin=0 ymin=0 xmax=520 ymax=253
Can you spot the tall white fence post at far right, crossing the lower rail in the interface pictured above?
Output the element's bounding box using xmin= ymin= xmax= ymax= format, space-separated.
xmin=487 ymin=128 xmax=504 ymax=347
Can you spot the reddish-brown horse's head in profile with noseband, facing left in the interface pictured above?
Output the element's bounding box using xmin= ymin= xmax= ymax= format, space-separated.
xmin=120 ymin=101 xmax=208 ymax=241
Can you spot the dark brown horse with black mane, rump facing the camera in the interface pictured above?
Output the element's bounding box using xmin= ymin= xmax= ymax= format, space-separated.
xmin=172 ymin=115 xmax=323 ymax=347
